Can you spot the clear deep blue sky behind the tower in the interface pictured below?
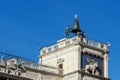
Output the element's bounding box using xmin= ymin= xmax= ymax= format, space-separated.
xmin=0 ymin=0 xmax=120 ymax=80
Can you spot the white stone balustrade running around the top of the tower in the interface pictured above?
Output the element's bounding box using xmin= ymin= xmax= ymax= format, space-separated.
xmin=41 ymin=36 xmax=103 ymax=55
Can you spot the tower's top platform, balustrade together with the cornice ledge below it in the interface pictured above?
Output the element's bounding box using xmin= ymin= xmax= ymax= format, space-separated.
xmin=41 ymin=36 xmax=109 ymax=56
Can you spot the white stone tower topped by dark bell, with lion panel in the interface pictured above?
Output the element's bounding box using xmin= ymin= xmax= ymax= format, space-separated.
xmin=39 ymin=17 xmax=110 ymax=80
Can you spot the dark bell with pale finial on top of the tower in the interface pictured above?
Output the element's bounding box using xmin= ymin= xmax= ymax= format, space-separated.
xmin=71 ymin=15 xmax=81 ymax=35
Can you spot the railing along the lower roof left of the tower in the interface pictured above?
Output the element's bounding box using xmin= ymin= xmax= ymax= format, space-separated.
xmin=0 ymin=52 xmax=60 ymax=74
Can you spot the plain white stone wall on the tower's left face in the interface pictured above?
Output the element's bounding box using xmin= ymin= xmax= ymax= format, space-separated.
xmin=42 ymin=45 xmax=79 ymax=74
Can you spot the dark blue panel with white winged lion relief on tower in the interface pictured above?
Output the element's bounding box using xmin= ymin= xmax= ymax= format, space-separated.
xmin=81 ymin=53 xmax=103 ymax=76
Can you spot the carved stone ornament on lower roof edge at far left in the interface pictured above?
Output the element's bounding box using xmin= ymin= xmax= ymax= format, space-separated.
xmin=0 ymin=57 xmax=26 ymax=75
